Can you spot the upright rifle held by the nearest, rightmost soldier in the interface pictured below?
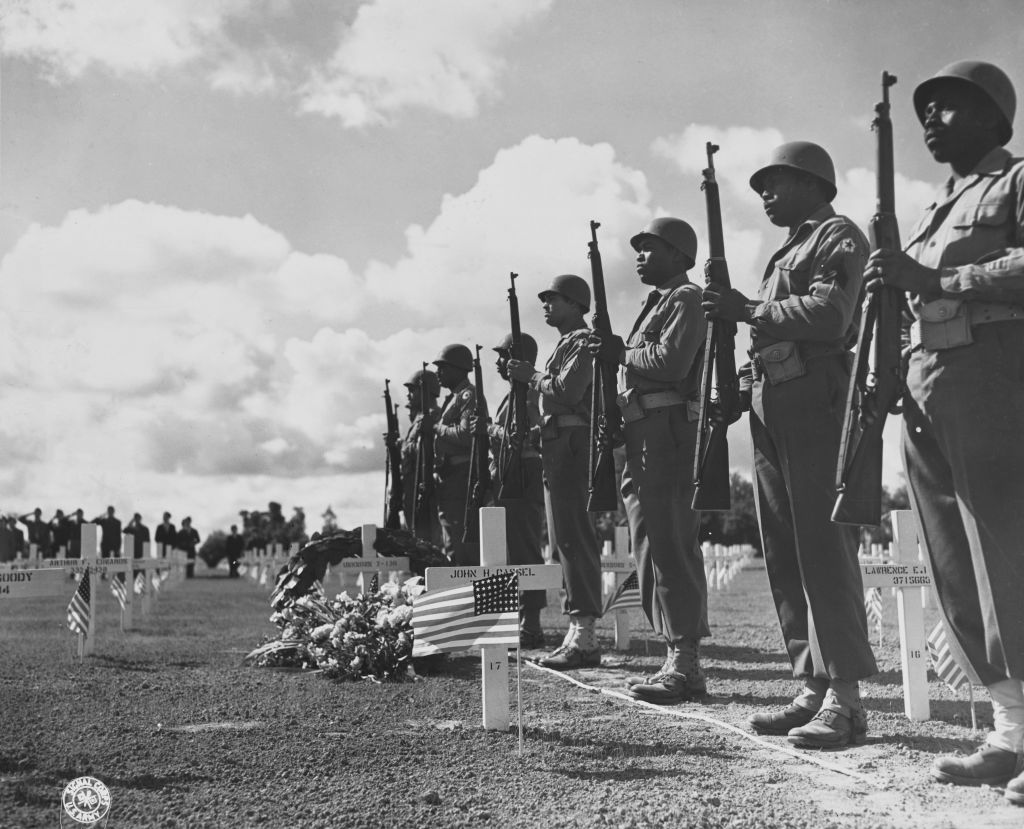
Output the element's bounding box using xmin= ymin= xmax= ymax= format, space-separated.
xmin=831 ymin=72 xmax=903 ymax=526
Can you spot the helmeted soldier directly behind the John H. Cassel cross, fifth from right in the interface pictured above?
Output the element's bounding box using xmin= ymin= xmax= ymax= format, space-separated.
xmin=487 ymin=334 xmax=547 ymax=649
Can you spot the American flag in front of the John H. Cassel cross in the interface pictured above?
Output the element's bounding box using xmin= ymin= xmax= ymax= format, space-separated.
xmin=413 ymin=573 xmax=519 ymax=656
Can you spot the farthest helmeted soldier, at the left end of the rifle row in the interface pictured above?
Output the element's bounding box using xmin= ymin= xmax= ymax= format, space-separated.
xmin=401 ymin=368 xmax=441 ymax=547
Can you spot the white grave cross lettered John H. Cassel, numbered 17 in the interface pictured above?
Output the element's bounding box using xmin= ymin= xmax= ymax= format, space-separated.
xmin=426 ymin=507 xmax=562 ymax=731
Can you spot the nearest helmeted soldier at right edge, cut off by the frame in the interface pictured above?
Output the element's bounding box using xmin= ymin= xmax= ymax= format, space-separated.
xmin=866 ymin=60 xmax=1024 ymax=804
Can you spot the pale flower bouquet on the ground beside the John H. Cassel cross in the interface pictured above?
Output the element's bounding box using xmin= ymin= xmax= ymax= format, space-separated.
xmin=245 ymin=576 xmax=425 ymax=681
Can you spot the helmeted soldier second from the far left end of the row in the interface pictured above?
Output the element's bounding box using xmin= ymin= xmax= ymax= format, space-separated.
xmin=434 ymin=344 xmax=480 ymax=565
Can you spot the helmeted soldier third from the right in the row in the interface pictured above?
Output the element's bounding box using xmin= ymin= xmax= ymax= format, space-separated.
xmin=590 ymin=217 xmax=711 ymax=704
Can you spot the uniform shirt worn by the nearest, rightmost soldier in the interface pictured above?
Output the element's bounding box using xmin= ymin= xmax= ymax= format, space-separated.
xmin=905 ymin=147 xmax=1024 ymax=304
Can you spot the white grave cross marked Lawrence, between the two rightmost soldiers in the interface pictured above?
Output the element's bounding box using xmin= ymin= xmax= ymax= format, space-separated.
xmin=860 ymin=510 xmax=932 ymax=723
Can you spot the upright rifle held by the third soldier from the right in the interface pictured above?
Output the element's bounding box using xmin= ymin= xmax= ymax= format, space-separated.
xmin=587 ymin=221 xmax=623 ymax=513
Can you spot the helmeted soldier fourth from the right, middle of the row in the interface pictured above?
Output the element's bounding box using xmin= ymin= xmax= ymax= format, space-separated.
xmin=509 ymin=273 xmax=601 ymax=670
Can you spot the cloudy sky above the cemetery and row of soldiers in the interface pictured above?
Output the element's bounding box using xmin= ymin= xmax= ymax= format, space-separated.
xmin=0 ymin=0 xmax=1024 ymax=534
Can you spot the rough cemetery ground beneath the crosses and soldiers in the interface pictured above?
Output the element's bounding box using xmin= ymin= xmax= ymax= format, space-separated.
xmin=0 ymin=560 xmax=1024 ymax=829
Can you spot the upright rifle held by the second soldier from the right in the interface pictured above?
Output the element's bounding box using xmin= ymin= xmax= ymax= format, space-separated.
xmin=690 ymin=141 xmax=739 ymax=513
